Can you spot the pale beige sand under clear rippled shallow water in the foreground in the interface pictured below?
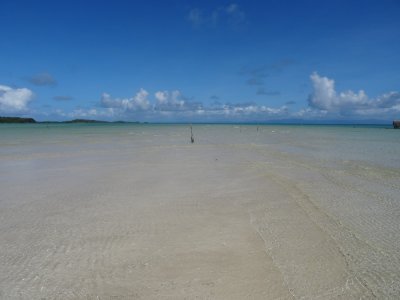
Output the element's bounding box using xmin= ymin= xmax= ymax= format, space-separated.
xmin=0 ymin=126 xmax=400 ymax=299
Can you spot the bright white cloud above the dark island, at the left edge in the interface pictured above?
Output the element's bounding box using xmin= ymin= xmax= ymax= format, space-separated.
xmin=0 ymin=85 xmax=33 ymax=112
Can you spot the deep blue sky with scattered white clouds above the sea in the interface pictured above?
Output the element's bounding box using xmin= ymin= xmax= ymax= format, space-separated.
xmin=0 ymin=0 xmax=400 ymax=123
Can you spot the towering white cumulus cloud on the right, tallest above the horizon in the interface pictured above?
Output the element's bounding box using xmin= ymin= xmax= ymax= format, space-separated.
xmin=308 ymin=72 xmax=400 ymax=117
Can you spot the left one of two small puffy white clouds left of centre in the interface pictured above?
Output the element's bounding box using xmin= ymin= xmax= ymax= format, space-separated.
xmin=100 ymin=89 xmax=150 ymax=111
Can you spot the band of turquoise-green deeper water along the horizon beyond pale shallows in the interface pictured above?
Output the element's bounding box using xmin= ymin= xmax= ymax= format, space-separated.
xmin=0 ymin=124 xmax=400 ymax=169
